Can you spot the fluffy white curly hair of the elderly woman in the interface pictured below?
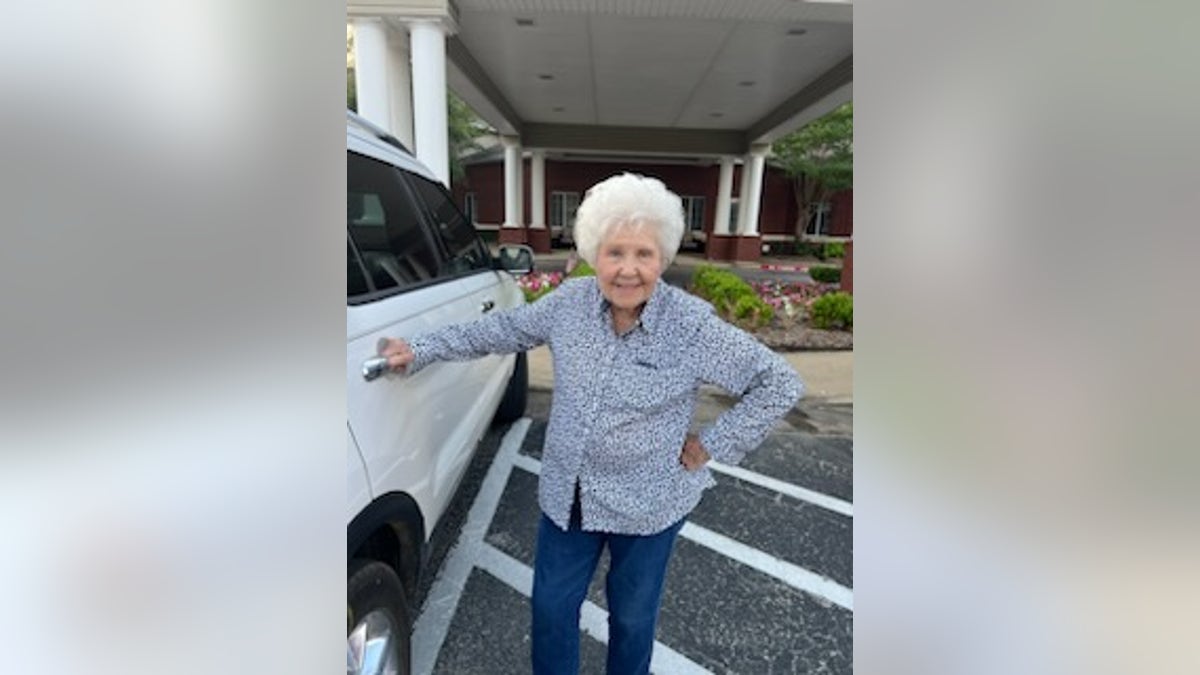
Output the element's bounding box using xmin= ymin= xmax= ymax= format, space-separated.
xmin=574 ymin=173 xmax=684 ymax=269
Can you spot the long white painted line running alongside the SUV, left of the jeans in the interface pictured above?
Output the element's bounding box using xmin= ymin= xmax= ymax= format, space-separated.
xmin=412 ymin=417 xmax=532 ymax=675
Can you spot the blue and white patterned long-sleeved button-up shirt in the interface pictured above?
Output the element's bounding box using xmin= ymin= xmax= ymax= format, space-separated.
xmin=408 ymin=277 xmax=804 ymax=534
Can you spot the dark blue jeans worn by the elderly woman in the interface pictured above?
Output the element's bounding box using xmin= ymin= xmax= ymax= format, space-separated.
xmin=532 ymin=494 xmax=684 ymax=675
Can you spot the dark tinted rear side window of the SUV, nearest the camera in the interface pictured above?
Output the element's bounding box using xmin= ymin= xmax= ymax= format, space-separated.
xmin=346 ymin=153 xmax=442 ymax=292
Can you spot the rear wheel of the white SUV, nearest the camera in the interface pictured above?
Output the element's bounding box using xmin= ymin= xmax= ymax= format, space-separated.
xmin=346 ymin=560 xmax=413 ymax=675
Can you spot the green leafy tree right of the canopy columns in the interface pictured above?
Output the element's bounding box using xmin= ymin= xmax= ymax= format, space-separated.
xmin=772 ymin=102 xmax=854 ymax=241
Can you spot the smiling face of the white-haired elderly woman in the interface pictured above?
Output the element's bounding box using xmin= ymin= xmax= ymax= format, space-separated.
xmin=596 ymin=227 xmax=662 ymax=312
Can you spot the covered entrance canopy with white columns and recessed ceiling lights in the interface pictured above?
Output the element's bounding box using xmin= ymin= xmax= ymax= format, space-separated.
xmin=348 ymin=0 xmax=853 ymax=254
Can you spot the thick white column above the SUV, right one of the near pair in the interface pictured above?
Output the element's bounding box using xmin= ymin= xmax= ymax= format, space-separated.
xmin=409 ymin=22 xmax=450 ymax=186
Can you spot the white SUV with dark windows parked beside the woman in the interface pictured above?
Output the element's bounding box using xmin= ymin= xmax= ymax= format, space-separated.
xmin=346 ymin=113 xmax=533 ymax=674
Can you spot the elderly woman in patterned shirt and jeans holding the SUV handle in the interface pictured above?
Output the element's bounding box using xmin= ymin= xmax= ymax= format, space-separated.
xmin=382 ymin=173 xmax=803 ymax=675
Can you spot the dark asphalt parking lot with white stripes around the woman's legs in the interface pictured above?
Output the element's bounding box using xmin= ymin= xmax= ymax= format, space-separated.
xmin=413 ymin=389 xmax=853 ymax=675
